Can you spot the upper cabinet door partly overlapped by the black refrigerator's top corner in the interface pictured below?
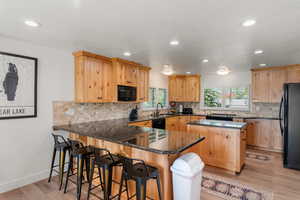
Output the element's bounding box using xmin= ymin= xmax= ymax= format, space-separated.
xmin=270 ymin=69 xmax=287 ymax=103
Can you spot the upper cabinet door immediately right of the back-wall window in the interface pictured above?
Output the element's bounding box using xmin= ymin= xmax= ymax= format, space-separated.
xmin=252 ymin=71 xmax=270 ymax=102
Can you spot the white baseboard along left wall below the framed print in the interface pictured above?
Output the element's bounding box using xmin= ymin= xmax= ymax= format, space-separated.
xmin=0 ymin=169 xmax=49 ymax=193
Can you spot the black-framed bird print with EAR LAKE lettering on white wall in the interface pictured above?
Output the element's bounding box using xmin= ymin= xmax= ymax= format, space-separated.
xmin=0 ymin=52 xmax=38 ymax=119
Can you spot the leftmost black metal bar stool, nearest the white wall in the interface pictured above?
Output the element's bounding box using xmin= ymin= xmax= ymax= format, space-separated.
xmin=48 ymin=133 xmax=71 ymax=190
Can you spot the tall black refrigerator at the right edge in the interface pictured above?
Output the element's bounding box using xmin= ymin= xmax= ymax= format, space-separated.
xmin=279 ymin=83 xmax=300 ymax=170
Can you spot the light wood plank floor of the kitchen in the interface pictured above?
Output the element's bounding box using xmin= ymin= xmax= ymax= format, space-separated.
xmin=0 ymin=150 xmax=300 ymax=200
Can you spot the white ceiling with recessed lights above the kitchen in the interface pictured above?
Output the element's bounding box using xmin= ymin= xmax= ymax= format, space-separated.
xmin=0 ymin=0 xmax=300 ymax=72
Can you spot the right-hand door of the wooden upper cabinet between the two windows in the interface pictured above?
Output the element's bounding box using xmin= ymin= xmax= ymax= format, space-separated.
xmin=184 ymin=76 xmax=200 ymax=102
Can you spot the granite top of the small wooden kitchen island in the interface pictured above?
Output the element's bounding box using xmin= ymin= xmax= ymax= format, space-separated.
xmin=188 ymin=119 xmax=247 ymax=129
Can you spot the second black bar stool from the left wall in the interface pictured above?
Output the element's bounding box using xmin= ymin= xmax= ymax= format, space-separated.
xmin=64 ymin=139 xmax=93 ymax=200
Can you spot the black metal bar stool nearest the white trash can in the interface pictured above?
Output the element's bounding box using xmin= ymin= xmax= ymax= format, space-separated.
xmin=119 ymin=157 xmax=162 ymax=200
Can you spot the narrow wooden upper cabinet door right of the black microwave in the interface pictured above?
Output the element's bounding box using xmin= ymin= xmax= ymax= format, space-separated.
xmin=137 ymin=69 xmax=149 ymax=102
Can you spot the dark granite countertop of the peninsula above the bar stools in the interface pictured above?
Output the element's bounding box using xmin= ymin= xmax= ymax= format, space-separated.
xmin=53 ymin=118 xmax=205 ymax=154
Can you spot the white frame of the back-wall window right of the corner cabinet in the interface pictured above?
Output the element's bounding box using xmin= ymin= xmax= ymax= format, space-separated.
xmin=200 ymin=85 xmax=252 ymax=112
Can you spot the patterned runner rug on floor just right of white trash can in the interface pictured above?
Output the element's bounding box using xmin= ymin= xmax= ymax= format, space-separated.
xmin=202 ymin=172 xmax=273 ymax=200
